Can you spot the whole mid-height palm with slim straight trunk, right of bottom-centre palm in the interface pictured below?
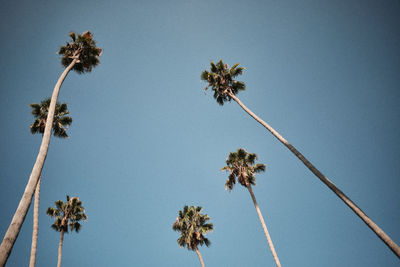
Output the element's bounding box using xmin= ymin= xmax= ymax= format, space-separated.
xmin=221 ymin=148 xmax=281 ymax=267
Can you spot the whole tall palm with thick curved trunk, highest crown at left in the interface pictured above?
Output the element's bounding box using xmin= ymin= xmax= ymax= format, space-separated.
xmin=0 ymin=31 xmax=102 ymax=266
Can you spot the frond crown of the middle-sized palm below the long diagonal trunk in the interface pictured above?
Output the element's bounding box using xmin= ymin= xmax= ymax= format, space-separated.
xmin=221 ymin=148 xmax=266 ymax=192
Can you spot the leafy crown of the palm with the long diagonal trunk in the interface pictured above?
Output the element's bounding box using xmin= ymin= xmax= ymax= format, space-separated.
xmin=200 ymin=59 xmax=246 ymax=106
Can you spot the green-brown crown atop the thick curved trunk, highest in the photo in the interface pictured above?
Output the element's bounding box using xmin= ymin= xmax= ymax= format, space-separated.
xmin=58 ymin=31 xmax=102 ymax=74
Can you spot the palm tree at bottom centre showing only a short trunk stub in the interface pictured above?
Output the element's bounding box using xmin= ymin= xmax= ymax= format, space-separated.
xmin=172 ymin=206 xmax=214 ymax=267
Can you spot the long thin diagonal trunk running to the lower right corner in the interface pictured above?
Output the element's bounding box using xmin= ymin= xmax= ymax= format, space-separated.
xmin=229 ymin=93 xmax=400 ymax=258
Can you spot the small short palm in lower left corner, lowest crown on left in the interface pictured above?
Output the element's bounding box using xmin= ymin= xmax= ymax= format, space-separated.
xmin=46 ymin=196 xmax=87 ymax=267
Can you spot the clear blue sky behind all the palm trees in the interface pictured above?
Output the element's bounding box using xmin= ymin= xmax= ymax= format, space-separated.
xmin=0 ymin=0 xmax=400 ymax=267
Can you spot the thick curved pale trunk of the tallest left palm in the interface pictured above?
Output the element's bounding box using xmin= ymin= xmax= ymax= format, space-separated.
xmin=0 ymin=59 xmax=78 ymax=267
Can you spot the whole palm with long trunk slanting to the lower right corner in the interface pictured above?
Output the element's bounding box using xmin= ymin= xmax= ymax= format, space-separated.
xmin=201 ymin=60 xmax=400 ymax=258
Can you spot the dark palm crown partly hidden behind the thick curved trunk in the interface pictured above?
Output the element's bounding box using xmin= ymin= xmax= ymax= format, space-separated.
xmin=30 ymin=98 xmax=72 ymax=138
